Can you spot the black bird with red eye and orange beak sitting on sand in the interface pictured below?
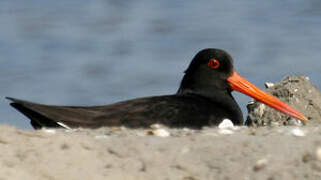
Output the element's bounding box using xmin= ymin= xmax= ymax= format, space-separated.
xmin=7 ymin=49 xmax=307 ymax=129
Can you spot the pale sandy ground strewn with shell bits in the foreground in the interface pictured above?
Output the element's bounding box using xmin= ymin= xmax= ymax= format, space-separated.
xmin=0 ymin=126 xmax=321 ymax=180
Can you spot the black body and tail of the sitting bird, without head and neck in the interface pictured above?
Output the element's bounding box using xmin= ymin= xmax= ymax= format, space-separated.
xmin=9 ymin=95 xmax=243 ymax=129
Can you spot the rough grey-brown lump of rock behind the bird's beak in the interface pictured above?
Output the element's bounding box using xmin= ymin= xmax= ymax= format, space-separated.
xmin=246 ymin=75 xmax=321 ymax=126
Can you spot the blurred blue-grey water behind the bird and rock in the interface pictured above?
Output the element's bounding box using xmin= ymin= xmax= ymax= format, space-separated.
xmin=0 ymin=0 xmax=321 ymax=129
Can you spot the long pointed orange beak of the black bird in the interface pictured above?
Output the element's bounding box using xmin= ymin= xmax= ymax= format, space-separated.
xmin=227 ymin=72 xmax=308 ymax=122
